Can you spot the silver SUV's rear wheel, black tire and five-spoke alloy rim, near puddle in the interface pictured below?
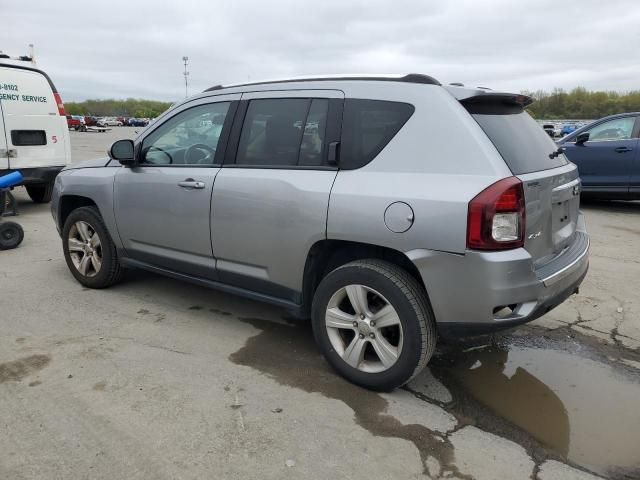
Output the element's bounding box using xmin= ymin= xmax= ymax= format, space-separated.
xmin=311 ymin=259 xmax=437 ymax=391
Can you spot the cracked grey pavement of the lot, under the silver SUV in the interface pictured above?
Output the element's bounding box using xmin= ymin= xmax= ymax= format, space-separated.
xmin=0 ymin=127 xmax=640 ymax=480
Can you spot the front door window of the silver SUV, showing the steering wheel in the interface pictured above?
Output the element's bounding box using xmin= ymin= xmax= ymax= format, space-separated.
xmin=141 ymin=102 xmax=230 ymax=165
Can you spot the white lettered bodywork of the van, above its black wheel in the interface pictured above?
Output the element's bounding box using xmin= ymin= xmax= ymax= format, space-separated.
xmin=0 ymin=66 xmax=68 ymax=169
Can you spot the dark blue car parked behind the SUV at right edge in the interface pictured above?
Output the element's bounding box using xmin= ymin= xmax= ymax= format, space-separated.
xmin=562 ymin=117 xmax=638 ymax=197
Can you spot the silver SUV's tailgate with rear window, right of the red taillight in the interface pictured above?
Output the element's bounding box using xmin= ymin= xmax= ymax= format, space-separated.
xmin=467 ymin=105 xmax=580 ymax=266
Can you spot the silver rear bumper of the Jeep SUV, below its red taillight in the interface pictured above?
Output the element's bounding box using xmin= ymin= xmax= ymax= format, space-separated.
xmin=407 ymin=216 xmax=589 ymax=338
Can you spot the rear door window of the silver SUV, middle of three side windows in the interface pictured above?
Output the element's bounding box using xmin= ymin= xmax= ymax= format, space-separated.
xmin=236 ymin=98 xmax=329 ymax=167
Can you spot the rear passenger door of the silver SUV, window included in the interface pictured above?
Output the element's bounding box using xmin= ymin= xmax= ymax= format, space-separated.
xmin=211 ymin=90 xmax=344 ymax=304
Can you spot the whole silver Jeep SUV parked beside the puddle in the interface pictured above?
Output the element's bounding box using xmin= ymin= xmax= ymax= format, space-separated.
xmin=52 ymin=74 xmax=589 ymax=390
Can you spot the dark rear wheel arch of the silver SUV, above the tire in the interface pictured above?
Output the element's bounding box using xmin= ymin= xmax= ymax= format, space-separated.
xmin=300 ymin=239 xmax=426 ymax=316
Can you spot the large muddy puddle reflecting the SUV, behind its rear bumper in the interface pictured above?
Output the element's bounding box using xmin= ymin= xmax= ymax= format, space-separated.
xmin=436 ymin=347 xmax=640 ymax=478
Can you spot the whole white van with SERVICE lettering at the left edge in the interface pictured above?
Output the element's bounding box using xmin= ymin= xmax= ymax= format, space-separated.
xmin=0 ymin=63 xmax=71 ymax=203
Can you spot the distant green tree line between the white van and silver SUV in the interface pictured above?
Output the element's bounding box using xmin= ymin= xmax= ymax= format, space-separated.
xmin=64 ymin=98 xmax=172 ymax=118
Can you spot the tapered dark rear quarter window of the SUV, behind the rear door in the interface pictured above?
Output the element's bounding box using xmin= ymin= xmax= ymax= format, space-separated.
xmin=340 ymin=99 xmax=415 ymax=169
